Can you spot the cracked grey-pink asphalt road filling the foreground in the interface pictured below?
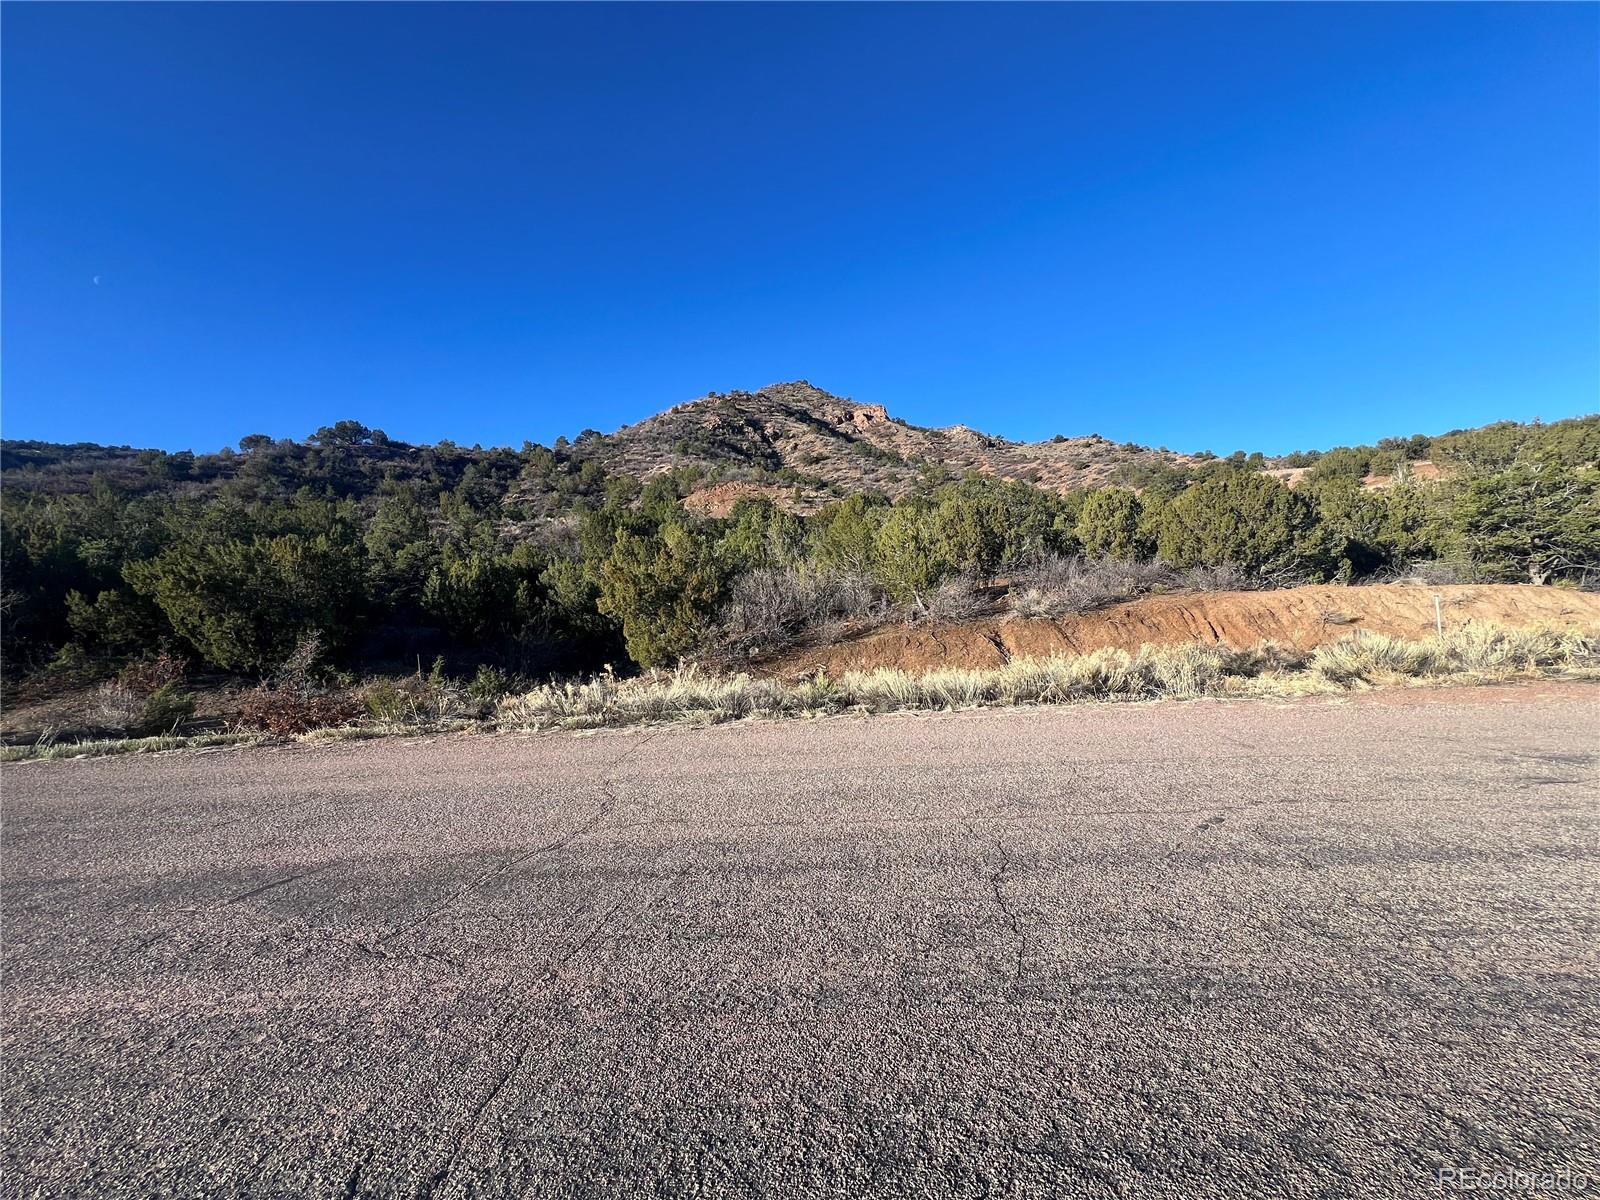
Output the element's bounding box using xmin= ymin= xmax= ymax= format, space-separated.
xmin=0 ymin=685 xmax=1600 ymax=1197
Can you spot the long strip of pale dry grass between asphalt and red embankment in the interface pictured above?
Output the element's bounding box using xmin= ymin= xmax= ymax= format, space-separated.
xmin=498 ymin=629 xmax=1600 ymax=730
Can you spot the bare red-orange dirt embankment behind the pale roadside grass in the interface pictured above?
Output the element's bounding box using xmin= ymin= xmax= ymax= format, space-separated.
xmin=758 ymin=584 xmax=1600 ymax=678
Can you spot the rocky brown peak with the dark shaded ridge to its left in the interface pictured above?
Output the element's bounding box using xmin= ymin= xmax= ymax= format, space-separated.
xmin=0 ymin=381 xmax=1198 ymax=515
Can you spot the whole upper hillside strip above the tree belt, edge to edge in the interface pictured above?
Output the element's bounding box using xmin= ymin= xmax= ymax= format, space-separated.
xmin=0 ymin=381 xmax=1600 ymax=518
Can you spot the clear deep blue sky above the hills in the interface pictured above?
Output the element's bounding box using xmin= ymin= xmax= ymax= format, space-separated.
xmin=0 ymin=3 xmax=1600 ymax=453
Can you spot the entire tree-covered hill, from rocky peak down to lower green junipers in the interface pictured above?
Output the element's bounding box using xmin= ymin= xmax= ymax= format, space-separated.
xmin=0 ymin=384 xmax=1600 ymax=704
